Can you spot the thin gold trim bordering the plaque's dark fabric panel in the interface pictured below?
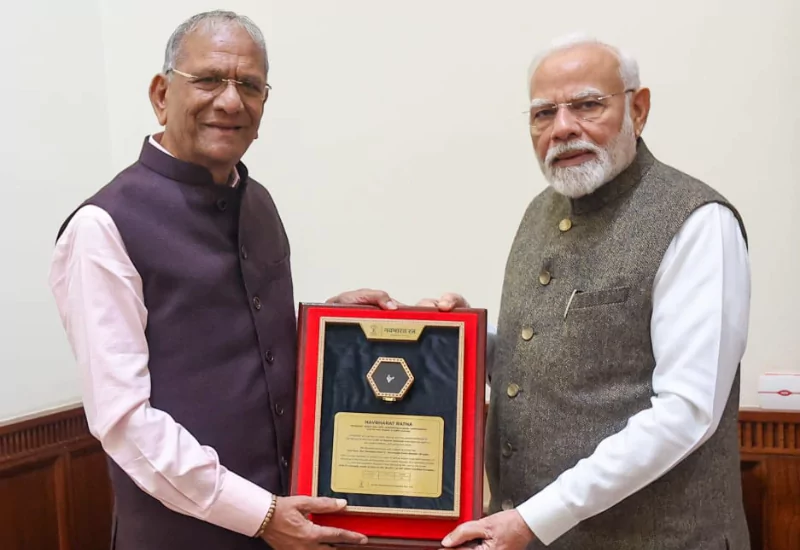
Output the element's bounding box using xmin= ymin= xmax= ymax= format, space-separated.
xmin=311 ymin=317 xmax=465 ymax=518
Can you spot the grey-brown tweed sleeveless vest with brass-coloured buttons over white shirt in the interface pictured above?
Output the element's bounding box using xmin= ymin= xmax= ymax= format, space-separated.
xmin=486 ymin=140 xmax=749 ymax=550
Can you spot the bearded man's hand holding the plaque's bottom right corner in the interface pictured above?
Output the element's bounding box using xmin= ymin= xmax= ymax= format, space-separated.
xmin=442 ymin=510 xmax=536 ymax=550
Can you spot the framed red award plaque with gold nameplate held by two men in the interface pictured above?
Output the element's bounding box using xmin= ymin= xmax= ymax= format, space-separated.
xmin=291 ymin=304 xmax=486 ymax=548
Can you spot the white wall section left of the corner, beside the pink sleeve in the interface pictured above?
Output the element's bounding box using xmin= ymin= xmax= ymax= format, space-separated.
xmin=0 ymin=0 xmax=111 ymax=420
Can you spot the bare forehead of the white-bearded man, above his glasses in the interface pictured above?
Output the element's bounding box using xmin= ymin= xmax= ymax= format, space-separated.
xmin=531 ymin=44 xmax=622 ymax=101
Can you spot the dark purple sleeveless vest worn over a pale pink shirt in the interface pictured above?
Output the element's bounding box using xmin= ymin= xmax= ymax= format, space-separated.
xmin=59 ymin=140 xmax=296 ymax=550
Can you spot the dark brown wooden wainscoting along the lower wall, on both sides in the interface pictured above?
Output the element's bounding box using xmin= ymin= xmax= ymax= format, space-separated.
xmin=0 ymin=408 xmax=800 ymax=550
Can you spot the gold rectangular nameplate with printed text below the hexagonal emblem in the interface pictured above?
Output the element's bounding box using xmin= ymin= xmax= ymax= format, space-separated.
xmin=331 ymin=412 xmax=444 ymax=498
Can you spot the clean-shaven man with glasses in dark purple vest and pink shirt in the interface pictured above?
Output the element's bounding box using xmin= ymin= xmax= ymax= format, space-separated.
xmin=50 ymin=11 xmax=392 ymax=550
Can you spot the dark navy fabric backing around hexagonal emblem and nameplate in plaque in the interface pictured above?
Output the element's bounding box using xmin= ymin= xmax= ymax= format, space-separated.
xmin=318 ymin=323 xmax=459 ymax=510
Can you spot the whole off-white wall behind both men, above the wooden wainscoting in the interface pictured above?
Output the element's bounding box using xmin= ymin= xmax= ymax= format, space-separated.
xmin=0 ymin=0 xmax=800 ymax=426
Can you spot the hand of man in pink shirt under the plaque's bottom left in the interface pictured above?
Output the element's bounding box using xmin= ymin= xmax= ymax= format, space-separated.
xmin=261 ymin=496 xmax=367 ymax=550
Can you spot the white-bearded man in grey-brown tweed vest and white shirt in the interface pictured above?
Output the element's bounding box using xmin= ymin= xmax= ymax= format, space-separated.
xmin=420 ymin=34 xmax=750 ymax=550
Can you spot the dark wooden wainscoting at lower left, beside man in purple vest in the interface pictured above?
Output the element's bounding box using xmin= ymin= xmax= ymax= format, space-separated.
xmin=0 ymin=408 xmax=112 ymax=550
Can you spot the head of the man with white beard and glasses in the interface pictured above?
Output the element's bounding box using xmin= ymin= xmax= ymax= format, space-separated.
xmin=528 ymin=36 xmax=650 ymax=201
